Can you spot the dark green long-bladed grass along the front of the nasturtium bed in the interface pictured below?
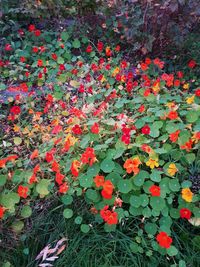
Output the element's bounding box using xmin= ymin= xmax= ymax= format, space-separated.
xmin=0 ymin=202 xmax=200 ymax=267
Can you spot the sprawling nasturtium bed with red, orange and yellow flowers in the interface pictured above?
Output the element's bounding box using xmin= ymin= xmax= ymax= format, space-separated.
xmin=0 ymin=25 xmax=200 ymax=266
